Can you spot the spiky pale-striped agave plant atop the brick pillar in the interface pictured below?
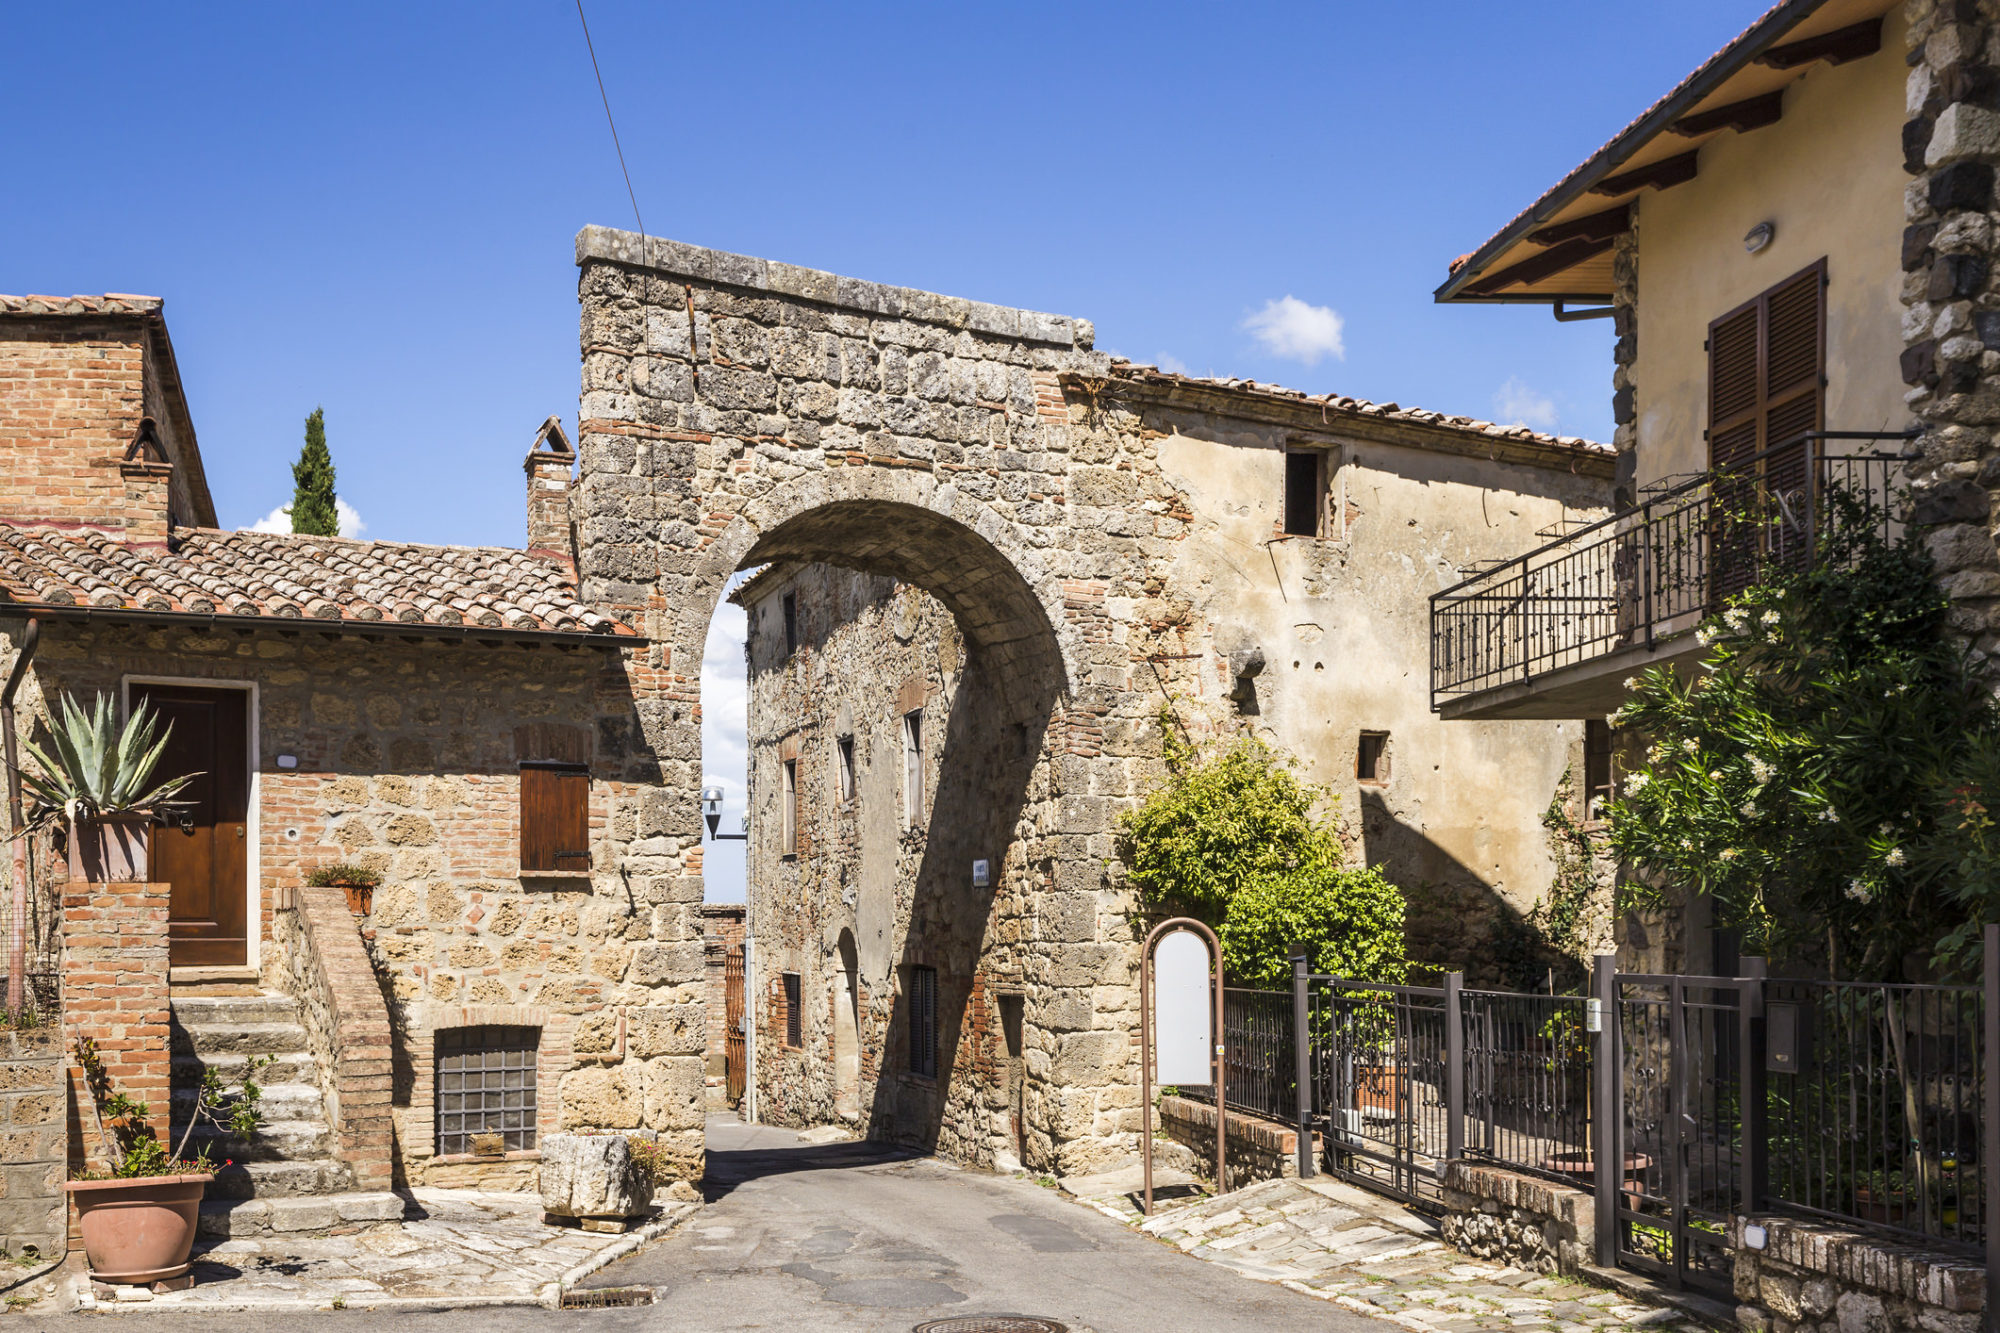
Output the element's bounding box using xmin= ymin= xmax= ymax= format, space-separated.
xmin=20 ymin=695 xmax=198 ymax=829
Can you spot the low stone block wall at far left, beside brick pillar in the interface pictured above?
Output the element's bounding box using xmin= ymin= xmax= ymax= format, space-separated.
xmin=0 ymin=1027 xmax=70 ymax=1271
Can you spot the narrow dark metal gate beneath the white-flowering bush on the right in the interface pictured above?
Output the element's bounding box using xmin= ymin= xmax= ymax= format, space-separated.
xmin=1600 ymin=973 xmax=1762 ymax=1295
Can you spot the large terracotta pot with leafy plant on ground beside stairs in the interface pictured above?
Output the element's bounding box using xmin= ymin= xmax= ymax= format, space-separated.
xmin=64 ymin=1037 xmax=270 ymax=1285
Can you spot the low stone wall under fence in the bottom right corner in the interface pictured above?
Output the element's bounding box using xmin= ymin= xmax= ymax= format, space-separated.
xmin=1730 ymin=1217 xmax=1986 ymax=1333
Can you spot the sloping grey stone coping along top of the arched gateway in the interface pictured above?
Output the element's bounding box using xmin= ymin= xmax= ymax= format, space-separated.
xmin=576 ymin=226 xmax=1096 ymax=350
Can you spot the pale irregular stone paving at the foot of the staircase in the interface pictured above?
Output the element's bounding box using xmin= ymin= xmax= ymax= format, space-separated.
xmin=76 ymin=1189 xmax=698 ymax=1313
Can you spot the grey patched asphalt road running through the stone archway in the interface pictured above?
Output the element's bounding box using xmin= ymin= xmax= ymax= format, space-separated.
xmin=19 ymin=1119 xmax=1388 ymax=1333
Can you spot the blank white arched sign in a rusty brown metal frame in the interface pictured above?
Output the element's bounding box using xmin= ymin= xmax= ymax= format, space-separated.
xmin=1138 ymin=917 xmax=1228 ymax=1217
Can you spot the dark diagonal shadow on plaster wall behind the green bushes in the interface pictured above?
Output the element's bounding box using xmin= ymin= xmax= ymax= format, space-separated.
xmin=1360 ymin=789 xmax=1586 ymax=993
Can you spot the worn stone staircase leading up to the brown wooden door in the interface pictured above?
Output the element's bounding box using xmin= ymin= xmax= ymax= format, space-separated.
xmin=172 ymin=991 xmax=402 ymax=1237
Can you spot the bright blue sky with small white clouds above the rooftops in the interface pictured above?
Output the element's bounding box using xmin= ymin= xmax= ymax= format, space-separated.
xmin=11 ymin=0 xmax=1760 ymax=889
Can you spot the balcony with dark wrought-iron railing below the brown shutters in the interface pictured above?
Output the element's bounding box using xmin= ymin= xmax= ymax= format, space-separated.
xmin=1430 ymin=430 xmax=1908 ymax=719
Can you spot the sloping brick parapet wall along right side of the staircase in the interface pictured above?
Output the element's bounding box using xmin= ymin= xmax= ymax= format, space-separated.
xmin=278 ymin=885 xmax=396 ymax=1191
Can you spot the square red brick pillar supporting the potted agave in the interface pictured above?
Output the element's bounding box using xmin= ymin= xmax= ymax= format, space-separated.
xmin=62 ymin=883 xmax=174 ymax=1169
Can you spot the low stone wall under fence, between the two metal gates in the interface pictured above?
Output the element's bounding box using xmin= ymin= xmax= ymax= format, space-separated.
xmin=1438 ymin=1161 xmax=1598 ymax=1275
